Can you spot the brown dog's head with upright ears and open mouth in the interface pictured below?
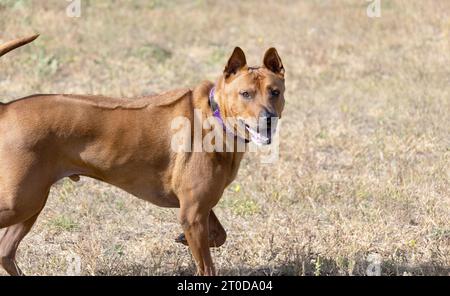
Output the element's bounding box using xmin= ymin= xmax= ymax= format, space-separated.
xmin=216 ymin=47 xmax=285 ymax=145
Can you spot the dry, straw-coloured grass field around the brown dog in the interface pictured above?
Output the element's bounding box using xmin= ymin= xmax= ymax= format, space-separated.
xmin=0 ymin=0 xmax=450 ymax=275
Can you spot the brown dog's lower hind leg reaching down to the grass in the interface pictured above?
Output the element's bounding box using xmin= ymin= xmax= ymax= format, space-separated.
xmin=0 ymin=213 xmax=39 ymax=276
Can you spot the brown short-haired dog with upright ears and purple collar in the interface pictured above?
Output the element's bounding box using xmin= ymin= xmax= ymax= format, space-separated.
xmin=0 ymin=36 xmax=284 ymax=275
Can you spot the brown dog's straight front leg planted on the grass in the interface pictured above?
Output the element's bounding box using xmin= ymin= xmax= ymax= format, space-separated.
xmin=180 ymin=204 xmax=216 ymax=275
